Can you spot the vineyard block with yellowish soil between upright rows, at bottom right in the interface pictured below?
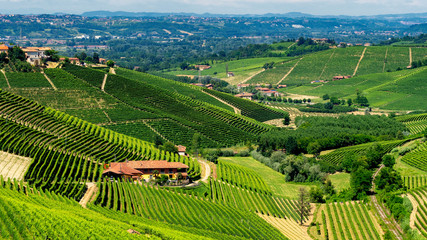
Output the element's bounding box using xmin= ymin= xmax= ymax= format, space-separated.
xmin=309 ymin=202 xmax=382 ymax=240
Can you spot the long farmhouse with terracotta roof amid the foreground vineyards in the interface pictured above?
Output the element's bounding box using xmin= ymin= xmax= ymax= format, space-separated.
xmin=102 ymin=160 xmax=188 ymax=181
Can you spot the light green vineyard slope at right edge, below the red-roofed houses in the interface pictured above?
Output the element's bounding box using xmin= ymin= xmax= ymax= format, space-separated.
xmin=281 ymin=67 xmax=427 ymax=111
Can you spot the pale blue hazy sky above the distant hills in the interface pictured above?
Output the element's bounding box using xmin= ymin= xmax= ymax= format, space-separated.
xmin=0 ymin=0 xmax=427 ymax=15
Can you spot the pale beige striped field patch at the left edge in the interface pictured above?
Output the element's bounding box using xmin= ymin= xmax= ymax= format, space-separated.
xmin=0 ymin=151 xmax=31 ymax=181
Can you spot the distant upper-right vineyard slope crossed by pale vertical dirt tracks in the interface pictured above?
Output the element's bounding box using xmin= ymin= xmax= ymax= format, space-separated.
xmin=237 ymin=46 xmax=427 ymax=86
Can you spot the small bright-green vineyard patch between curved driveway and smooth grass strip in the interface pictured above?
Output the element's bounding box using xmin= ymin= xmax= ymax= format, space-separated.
xmin=217 ymin=160 xmax=271 ymax=194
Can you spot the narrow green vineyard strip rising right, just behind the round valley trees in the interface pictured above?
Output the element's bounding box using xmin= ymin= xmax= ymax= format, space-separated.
xmin=319 ymin=140 xmax=407 ymax=164
